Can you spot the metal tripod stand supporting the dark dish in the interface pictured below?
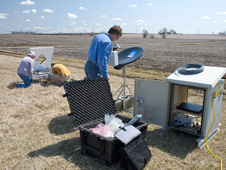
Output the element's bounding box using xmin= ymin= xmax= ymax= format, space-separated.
xmin=114 ymin=66 xmax=133 ymax=110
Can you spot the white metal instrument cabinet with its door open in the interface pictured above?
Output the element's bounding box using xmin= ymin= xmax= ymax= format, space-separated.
xmin=134 ymin=66 xmax=226 ymax=148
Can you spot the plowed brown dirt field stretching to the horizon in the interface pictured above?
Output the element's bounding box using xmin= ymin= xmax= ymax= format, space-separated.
xmin=0 ymin=34 xmax=226 ymax=72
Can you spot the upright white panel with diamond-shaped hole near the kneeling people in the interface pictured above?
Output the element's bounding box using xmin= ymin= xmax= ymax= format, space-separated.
xmin=30 ymin=47 xmax=54 ymax=71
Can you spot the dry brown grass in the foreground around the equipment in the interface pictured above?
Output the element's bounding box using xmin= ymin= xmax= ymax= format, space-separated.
xmin=0 ymin=55 xmax=226 ymax=170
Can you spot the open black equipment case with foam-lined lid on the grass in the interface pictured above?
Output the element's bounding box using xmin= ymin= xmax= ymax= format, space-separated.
xmin=64 ymin=78 xmax=148 ymax=165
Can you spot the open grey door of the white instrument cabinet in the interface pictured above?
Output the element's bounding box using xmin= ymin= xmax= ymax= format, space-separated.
xmin=134 ymin=79 xmax=169 ymax=126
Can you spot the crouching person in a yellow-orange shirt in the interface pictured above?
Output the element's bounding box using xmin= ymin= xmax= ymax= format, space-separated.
xmin=50 ymin=63 xmax=71 ymax=86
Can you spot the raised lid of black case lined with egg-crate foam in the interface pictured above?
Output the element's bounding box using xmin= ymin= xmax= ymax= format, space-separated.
xmin=64 ymin=78 xmax=116 ymax=126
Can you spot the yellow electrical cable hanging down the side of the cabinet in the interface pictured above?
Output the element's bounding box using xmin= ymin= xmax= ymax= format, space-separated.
xmin=206 ymin=83 xmax=223 ymax=170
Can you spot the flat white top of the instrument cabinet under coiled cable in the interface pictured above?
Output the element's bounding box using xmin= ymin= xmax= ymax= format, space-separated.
xmin=165 ymin=66 xmax=226 ymax=88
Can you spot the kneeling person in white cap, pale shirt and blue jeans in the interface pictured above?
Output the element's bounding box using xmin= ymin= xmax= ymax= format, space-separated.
xmin=16 ymin=51 xmax=35 ymax=88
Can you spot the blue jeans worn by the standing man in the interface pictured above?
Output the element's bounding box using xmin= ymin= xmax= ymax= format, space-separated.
xmin=85 ymin=61 xmax=100 ymax=79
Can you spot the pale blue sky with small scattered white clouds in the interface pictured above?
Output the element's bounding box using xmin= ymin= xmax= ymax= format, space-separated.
xmin=0 ymin=0 xmax=226 ymax=34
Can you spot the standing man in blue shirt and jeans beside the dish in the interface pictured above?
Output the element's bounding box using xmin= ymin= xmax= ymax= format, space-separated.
xmin=85 ymin=25 xmax=122 ymax=79
